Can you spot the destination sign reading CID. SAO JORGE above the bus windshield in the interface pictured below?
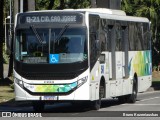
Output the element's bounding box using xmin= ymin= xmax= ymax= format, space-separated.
xmin=19 ymin=14 xmax=82 ymax=24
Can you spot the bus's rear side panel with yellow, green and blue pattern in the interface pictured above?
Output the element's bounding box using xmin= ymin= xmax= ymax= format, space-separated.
xmin=128 ymin=50 xmax=152 ymax=92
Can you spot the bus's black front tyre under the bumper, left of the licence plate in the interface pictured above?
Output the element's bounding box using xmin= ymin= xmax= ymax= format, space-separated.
xmin=32 ymin=101 xmax=45 ymax=112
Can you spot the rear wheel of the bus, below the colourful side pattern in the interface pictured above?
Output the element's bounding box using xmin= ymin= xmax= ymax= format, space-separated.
xmin=127 ymin=80 xmax=137 ymax=103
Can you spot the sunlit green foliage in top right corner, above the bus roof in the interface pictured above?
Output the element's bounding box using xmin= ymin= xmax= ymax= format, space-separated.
xmin=122 ymin=0 xmax=160 ymax=32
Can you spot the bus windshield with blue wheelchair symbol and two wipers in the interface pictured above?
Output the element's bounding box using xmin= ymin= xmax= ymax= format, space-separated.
xmin=15 ymin=25 xmax=87 ymax=64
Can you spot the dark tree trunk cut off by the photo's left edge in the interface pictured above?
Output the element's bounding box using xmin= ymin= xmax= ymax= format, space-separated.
xmin=0 ymin=0 xmax=4 ymax=79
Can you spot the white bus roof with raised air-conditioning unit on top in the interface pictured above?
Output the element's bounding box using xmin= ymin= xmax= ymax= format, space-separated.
xmin=20 ymin=8 xmax=149 ymax=22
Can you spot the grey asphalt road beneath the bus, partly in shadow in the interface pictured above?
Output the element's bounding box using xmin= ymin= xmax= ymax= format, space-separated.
xmin=0 ymin=91 xmax=160 ymax=120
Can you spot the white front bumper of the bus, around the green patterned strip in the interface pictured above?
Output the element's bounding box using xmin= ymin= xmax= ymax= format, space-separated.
xmin=14 ymin=69 xmax=90 ymax=101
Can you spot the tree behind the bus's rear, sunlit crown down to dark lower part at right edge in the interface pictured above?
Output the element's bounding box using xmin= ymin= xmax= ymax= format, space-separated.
xmin=122 ymin=0 xmax=160 ymax=65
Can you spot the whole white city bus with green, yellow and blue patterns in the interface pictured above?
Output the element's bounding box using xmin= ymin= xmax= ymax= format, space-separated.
xmin=14 ymin=8 xmax=152 ymax=111
